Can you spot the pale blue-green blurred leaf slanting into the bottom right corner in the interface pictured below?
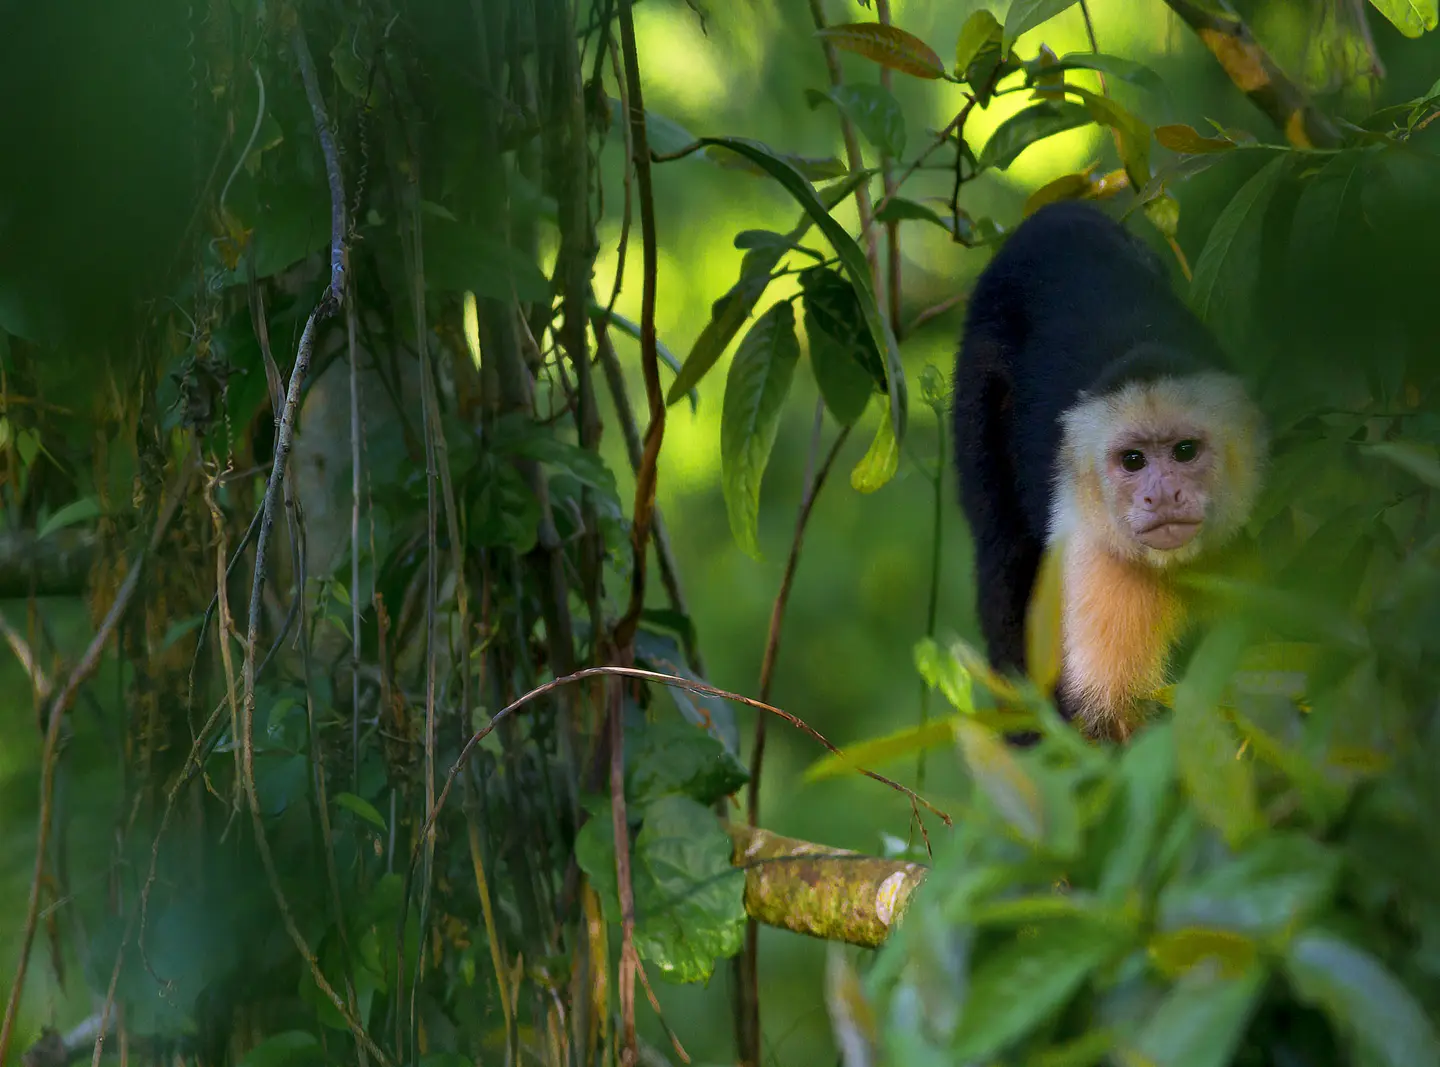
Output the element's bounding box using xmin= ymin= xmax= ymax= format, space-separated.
xmin=1284 ymin=930 xmax=1440 ymax=1067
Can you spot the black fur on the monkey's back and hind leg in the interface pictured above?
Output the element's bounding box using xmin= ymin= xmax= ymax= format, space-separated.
xmin=953 ymin=202 xmax=1223 ymax=679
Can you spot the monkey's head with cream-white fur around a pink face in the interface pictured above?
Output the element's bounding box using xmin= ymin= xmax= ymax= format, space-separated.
xmin=1056 ymin=355 xmax=1266 ymax=567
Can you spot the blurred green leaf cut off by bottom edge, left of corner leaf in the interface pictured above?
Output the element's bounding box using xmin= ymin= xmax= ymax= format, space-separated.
xmin=1122 ymin=966 xmax=1267 ymax=1067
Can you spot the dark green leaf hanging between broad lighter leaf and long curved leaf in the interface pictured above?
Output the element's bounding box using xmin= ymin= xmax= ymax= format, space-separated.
xmin=801 ymin=266 xmax=884 ymax=426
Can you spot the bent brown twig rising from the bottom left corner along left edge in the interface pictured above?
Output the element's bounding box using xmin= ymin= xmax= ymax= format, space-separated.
xmin=0 ymin=461 xmax=194 ymax=1063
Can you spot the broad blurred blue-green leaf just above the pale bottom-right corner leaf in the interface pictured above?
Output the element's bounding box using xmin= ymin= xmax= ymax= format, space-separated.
xmin=1156 ymin=831 xmax=1341 ymax=937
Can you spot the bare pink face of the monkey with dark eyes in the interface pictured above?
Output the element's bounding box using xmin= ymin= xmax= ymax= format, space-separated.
xmin=1106 ymin=433 xmax=1214 ymax=551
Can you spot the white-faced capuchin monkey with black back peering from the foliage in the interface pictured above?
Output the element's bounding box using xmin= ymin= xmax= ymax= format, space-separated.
xmin=955 ymin=202 xmax=1267 ymax=740
